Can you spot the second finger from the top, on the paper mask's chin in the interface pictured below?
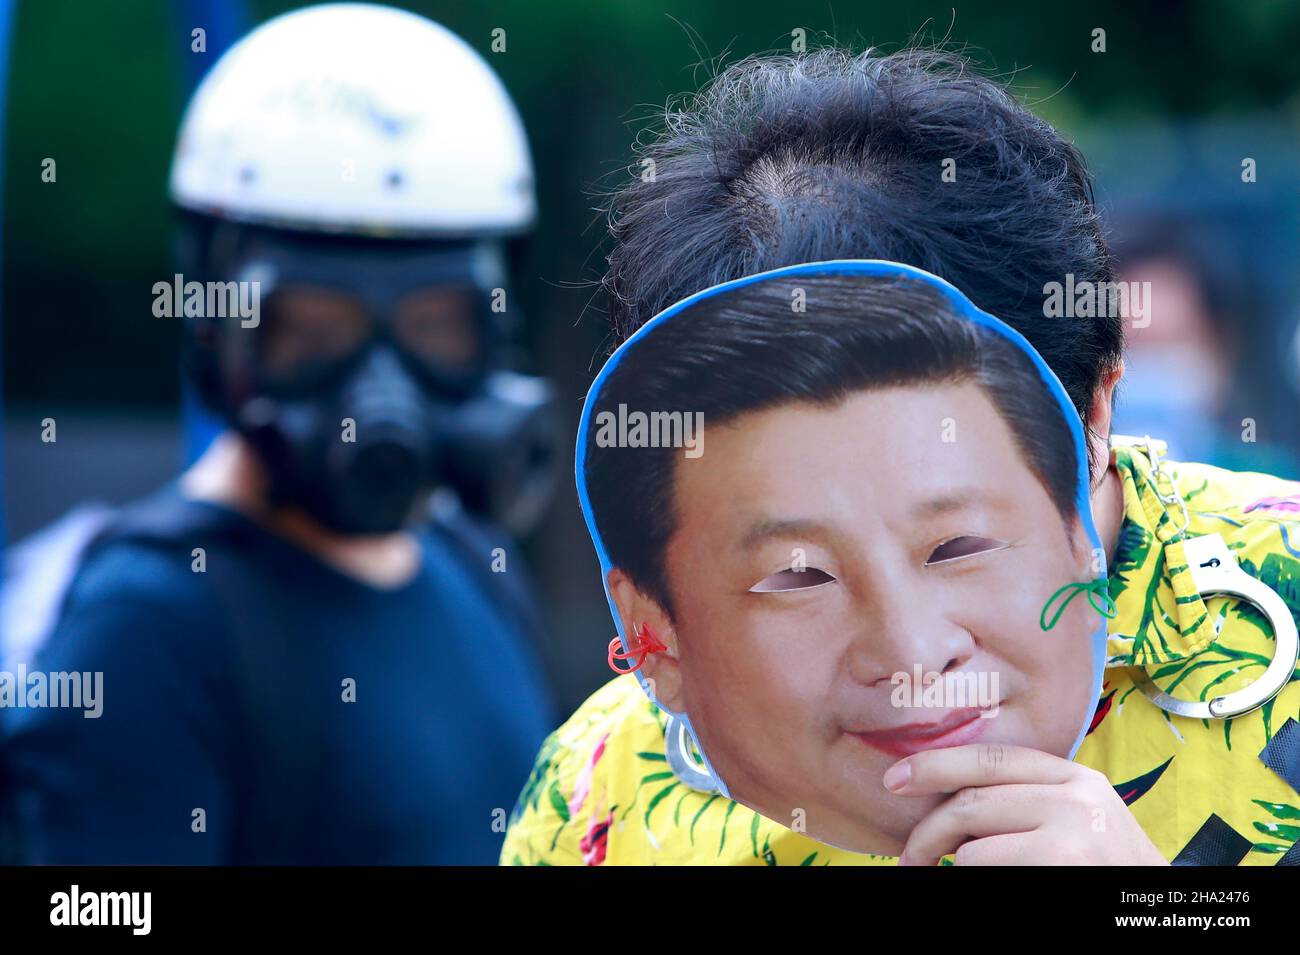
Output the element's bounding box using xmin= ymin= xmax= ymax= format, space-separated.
xmin=898 ymin=786 xmax=1058 ymax=865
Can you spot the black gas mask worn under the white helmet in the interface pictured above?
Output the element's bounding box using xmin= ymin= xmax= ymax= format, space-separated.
xmin=189 ymin=231 xmax=558 ymax=534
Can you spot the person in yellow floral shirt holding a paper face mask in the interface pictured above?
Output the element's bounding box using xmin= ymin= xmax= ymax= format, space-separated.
xmin=501 ymin=47 xmax=1300 ymax=867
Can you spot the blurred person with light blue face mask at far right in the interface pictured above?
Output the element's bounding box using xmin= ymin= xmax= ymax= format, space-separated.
xmin=1114 ymin=216 xmax=1300 ymax=478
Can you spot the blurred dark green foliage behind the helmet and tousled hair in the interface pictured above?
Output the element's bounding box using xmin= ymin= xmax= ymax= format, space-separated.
xmin=3 ymin=0 xmax=1300 ymax=404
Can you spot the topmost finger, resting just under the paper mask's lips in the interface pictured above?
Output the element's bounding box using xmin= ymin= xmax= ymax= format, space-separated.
xmin=884 ymin=743 xmax=1079 ymax=795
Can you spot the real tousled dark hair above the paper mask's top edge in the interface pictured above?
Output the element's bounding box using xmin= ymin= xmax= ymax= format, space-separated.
xmin=603 ymin=48 xmax=1123 ymax=439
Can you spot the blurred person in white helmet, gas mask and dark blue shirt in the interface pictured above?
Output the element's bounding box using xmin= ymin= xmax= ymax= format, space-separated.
xmin=5 ymin=4 xmax=555 ymax=864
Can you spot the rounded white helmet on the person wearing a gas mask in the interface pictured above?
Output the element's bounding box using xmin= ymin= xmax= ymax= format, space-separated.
xmin=170 ymin=4 xmax=536 ymax=236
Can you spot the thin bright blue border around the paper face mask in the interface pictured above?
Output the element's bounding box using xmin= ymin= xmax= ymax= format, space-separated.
xmin=575 ymin=259 xmax=1108 ymax=799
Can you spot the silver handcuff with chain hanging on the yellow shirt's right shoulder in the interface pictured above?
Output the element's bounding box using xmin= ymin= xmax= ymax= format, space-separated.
xmin=1134 ymin=435 xmax=1300 ymax=720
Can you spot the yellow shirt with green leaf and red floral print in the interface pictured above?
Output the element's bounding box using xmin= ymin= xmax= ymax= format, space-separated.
xmin=501 ymin=438 xmax=1300 ymax=865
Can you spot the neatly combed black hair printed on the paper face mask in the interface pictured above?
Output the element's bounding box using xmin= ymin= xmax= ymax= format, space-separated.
xmin=582 ymin=274 xmax=1079 ymax=615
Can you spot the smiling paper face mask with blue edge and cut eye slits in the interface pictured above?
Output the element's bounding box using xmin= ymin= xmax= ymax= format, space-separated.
xmin=577 ymin=261 xmax=1106 ymax=855
